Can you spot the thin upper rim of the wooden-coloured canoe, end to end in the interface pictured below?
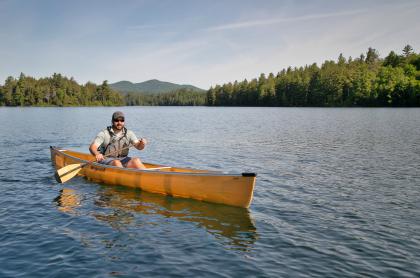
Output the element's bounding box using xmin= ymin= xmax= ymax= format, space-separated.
xmin=50 ymin=146 xmax=251 ymax=177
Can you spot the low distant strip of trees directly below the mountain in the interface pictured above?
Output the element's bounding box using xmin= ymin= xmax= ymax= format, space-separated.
xmin=124 ymin=89 xmax=206 ymax=106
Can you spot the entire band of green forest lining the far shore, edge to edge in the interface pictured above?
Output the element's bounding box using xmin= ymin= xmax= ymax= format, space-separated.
xmin=0 ymin=45 xmax=420 ymax=107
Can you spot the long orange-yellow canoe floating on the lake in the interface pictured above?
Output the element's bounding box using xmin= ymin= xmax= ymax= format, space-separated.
xmin=50 ymin=147 xmax=256 ymax=208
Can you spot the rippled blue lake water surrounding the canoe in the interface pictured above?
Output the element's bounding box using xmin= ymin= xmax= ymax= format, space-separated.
xmin=0 ymin=107 xmax=420 ymax=277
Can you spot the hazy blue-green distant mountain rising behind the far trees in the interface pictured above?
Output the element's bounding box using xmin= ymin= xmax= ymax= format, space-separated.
xmin=109 ymin=79 xmax=204 ymax=94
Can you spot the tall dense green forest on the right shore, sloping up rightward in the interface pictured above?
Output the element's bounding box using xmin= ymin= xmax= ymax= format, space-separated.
xmin=206 ymin=45 xmax=420 ymax=107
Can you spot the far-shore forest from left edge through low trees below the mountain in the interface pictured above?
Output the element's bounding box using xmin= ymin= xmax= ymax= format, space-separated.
xmin=0 ymin=73 xmax=206 ymax=106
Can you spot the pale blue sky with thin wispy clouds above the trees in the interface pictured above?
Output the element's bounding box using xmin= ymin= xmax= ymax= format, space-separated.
xmin=0 ymin=0 xmax=420 ymax=89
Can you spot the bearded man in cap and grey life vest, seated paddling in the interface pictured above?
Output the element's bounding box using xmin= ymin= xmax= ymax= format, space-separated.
xmin=89 ymin=111 xmax=147 ymax=169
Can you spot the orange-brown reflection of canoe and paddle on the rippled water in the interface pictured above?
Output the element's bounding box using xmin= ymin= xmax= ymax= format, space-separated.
xmin=56 ymin=186 xmax=257 ymax=251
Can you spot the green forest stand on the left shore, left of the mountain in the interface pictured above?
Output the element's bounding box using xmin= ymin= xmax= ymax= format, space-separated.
xmin=0 ymin=73 xmax=124 ymax=106
